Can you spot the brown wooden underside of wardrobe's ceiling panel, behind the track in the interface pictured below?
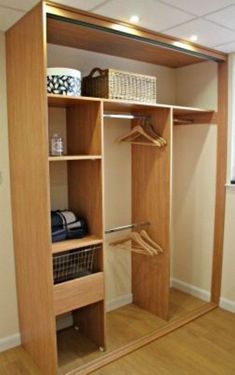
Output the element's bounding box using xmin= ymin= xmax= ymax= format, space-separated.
xmin=47 ymin=19 xmax=203 ymax=68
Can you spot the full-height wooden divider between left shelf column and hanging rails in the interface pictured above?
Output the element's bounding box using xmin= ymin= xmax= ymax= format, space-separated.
xmin=67 ymin=101 xmax=105 ymax=347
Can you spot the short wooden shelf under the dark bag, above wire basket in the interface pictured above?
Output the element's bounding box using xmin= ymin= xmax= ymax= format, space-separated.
xmin=52 ymin=235 xmax=103 ymax=254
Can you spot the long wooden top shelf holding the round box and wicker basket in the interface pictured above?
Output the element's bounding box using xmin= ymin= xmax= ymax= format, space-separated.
xmin=48 ymin=94 xmax=216 ymax=125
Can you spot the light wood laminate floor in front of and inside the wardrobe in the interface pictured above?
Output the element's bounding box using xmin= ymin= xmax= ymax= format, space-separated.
xmin=0 ymin=291 xmax=235 ymax=375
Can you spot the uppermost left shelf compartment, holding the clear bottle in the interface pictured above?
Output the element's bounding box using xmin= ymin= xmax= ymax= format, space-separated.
xmin=48 ymin=95 xmax=102 ymax=157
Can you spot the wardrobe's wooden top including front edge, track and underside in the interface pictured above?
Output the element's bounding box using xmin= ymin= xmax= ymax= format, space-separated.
xmin=47 ymin=5 xmax=226 ymax=67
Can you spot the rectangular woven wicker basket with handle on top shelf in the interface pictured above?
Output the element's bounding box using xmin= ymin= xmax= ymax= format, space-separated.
xmin=82 ymin=68 xmax=157 ymax=103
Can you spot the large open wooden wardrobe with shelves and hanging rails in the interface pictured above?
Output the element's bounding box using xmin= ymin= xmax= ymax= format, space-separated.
xmin=6 ymin=2 xmax=227 ymax=375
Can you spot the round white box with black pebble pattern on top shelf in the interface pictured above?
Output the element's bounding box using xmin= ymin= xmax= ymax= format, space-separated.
xmin=47 ymin=68 xmax=81 ymax=96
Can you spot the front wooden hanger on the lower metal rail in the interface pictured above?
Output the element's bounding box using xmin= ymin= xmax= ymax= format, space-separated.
xmin=110 ymin=232 xmax=159 ymax=256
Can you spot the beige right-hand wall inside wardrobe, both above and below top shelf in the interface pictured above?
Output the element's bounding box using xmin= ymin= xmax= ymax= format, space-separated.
xmin=171 ymin=62 xmax=217 ymax=297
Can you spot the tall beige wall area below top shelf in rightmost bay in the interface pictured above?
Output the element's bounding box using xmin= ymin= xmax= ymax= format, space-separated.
xmin=172 ymin=124 xmax=216 ymax=291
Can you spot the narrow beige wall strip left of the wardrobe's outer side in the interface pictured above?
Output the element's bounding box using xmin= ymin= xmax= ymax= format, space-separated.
xmin=0 ymin=33 xmax=20 ymax=347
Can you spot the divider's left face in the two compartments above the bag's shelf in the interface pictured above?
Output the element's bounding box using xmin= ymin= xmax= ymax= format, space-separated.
xmin=67 ymin=101 xmax=103 ymax=237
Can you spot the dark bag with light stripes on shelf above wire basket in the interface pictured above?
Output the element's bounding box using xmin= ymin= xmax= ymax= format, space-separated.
xmin=51 ymin=210 xmax=88 ymax=242
